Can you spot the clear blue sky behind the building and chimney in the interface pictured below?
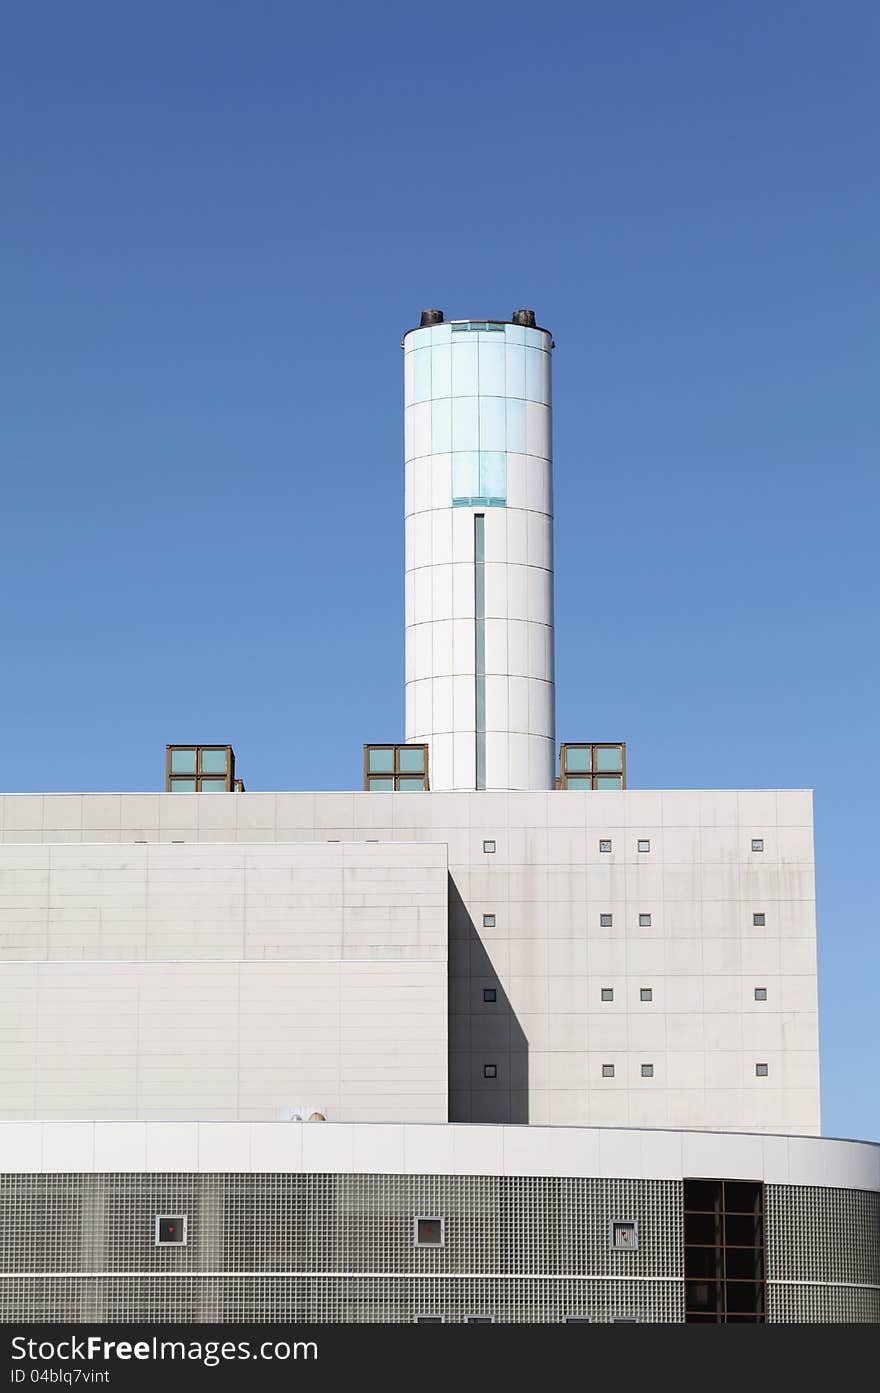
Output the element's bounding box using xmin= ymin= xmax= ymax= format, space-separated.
xmin=0 ymin=0 xmax=880 ymax=1137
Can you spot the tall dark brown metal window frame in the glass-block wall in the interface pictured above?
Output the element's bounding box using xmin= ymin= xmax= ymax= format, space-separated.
xmin=682 ymin=1176 xmax=767 ymax=1325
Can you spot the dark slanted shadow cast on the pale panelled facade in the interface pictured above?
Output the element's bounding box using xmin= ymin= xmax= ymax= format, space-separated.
xmin=447 ymin=876 xmax=529 ymax=1123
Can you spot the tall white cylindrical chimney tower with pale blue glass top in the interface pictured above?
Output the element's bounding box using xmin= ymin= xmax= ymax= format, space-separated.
xmin=404 ymin=317 xmax=556 ymax=790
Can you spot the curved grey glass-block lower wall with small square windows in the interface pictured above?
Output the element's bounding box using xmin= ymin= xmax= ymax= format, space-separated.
xmin=0 ymin=1144 xmax=880 ymax=1323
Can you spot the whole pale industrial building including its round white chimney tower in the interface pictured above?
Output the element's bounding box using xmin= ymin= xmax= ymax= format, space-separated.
xmin=0 ymin=311 xmax=880 ymax=1323
